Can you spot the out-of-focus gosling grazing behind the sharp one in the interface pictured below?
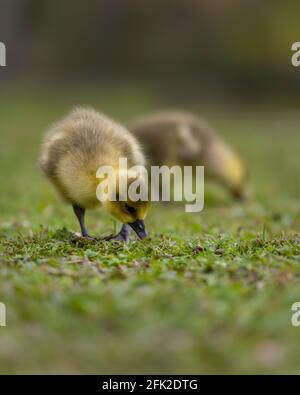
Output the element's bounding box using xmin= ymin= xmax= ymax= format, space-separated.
xmin=129 ymin=111 xmax=249 ymax=200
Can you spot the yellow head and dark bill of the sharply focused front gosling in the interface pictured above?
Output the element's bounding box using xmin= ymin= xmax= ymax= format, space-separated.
xmin=102 ymin=168 xmax=149 ymax=239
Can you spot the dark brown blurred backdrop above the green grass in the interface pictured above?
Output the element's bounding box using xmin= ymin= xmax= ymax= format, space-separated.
xmin=0 ymin=0 xmax=300 ymax=101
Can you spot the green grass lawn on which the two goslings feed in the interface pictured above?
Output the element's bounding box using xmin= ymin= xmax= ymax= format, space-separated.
xmin=0 ymin=88 xmax=300 ymax=373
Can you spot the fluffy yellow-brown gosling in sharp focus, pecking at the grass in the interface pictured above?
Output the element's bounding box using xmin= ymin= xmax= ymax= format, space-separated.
xmin=39 ymin=108 xmax=148 ymax=243
